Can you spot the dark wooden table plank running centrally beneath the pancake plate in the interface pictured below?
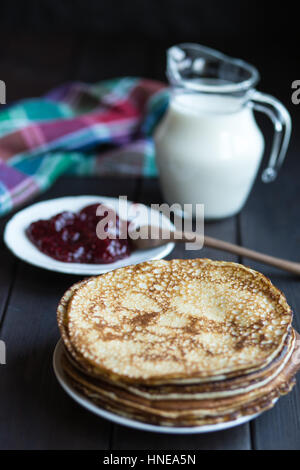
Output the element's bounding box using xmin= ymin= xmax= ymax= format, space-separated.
xmin=112 ymin=180 xmax=251 ymax=450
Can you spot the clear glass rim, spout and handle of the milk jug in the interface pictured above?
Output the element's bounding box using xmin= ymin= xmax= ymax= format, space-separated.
xmin=167 ymin=43 xmax=291 ymax=183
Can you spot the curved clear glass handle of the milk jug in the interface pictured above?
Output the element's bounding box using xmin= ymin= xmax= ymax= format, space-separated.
xmin=250 ymin=90 xmax=292 ymax=183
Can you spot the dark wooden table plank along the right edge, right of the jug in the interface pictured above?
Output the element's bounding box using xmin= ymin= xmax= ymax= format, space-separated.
xmin=240 ymin=156 xmax=300 ymax=450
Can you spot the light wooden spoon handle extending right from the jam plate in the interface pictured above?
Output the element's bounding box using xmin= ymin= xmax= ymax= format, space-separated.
xmin=175 ymin=232 xmax=300 ymax=276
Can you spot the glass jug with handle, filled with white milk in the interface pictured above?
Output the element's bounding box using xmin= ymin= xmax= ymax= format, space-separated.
xmin=154 ymin=44 xmax=291 ymax=219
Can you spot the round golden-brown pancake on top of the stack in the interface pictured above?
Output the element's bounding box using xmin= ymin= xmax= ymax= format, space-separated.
xmin=64 ymin=259 xmax=292 ymax=383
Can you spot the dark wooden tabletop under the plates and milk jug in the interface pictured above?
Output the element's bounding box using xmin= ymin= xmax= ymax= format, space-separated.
xmin=0 ymin=165 xmax=300 ymax=450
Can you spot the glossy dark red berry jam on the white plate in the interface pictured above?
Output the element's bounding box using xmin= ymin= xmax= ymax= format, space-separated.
xmin=26 ymin=204 xmax=131 ymax=264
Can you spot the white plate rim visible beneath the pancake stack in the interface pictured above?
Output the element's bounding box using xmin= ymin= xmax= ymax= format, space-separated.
xmin=53 ymin=339 xmax=260 ymax=434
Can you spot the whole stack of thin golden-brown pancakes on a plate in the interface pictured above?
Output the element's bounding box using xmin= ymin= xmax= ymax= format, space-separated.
xmin=58 ymin=259 xmax=297 ymax=426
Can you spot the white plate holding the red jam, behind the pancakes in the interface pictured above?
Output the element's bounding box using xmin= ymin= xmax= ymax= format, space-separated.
xmin=4 ymin=196 xmax=174 ymax=276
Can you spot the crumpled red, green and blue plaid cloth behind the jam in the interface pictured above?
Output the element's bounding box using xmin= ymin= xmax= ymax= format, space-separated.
xmin=0 ymin=78 xmax=168 ymax=215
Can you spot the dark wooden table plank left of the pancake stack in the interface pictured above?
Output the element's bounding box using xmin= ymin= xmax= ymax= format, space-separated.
xmin=0 ymin=178 xmax=136 ymax=449
